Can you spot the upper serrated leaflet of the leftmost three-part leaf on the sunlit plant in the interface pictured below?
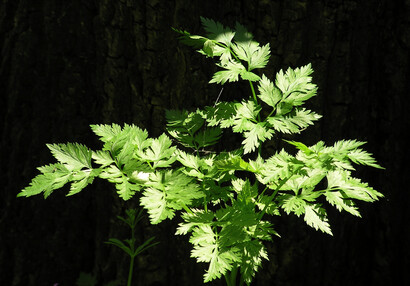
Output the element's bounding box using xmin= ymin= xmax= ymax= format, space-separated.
xmin=47 ymin=143 xmax=92 ymax=170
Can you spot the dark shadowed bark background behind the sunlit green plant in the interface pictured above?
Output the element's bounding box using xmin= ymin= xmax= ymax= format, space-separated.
xmin=0 ymin=0 xmax=410 ymax=286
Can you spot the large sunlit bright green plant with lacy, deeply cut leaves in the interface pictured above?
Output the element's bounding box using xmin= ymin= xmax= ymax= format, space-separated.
xmin=18 ymin=18 xmax=382 ymax=286
